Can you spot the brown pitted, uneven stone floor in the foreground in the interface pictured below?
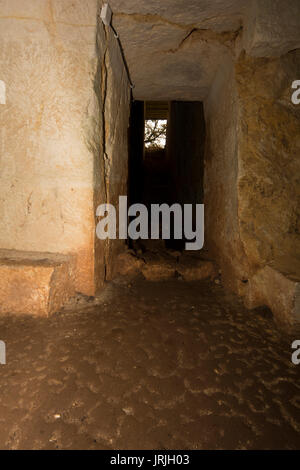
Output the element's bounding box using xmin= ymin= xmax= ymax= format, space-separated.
xmin=0 ymin=281 xmax=300 ymax=450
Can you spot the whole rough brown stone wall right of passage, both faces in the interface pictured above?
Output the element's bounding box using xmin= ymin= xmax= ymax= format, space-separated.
xmin=204 ymin=50 xmax=300 ymax=317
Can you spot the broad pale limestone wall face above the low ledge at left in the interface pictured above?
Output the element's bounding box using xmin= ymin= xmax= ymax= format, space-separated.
xmin=0 ymin=0 xmax=128 ymax=294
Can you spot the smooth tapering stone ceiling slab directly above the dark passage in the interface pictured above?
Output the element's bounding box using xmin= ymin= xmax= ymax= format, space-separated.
xmin=109 ymin=0 xmax=249 ymax=100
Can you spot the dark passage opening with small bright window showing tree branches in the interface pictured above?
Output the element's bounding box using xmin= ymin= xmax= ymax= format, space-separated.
xmin=128 ymin=101 xmax=205 ymax=251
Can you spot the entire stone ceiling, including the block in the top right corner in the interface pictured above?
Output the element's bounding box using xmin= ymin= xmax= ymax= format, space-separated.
xmin=108 ymin=0 xmax=300 ymax=101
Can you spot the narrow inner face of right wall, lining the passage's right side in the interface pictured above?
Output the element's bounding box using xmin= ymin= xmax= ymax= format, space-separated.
xmin=204 ymin=59 xmax=249 ymax=292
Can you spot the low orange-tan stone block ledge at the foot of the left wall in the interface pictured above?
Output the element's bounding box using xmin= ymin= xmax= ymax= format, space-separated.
xmin=0 ymin=250 xmax=75 ymax=317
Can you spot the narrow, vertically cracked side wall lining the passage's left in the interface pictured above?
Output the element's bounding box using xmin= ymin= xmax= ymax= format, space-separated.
xmin=90 ymin=26 xmax=131 ymax=282
